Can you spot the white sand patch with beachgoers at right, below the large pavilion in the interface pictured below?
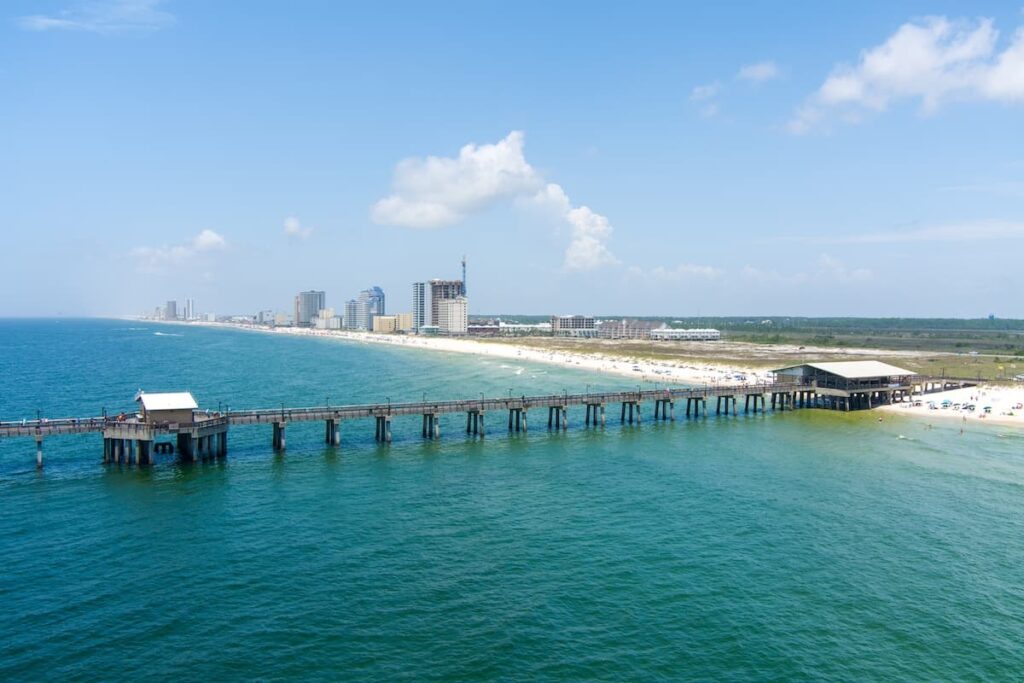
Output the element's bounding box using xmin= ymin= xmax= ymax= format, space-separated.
xmin=878 ymin=384 xmax=1024 ymax=427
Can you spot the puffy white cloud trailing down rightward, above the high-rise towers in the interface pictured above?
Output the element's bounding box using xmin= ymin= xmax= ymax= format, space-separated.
xmin=370 ymin=131 xmax=617 ymax=270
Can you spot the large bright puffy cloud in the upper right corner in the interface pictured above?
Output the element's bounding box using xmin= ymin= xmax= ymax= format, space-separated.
xmin=788 ymin=16 xmax=1024 ymax=133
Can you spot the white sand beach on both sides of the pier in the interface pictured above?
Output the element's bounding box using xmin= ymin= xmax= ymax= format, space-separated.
xmin=145 ymin=319 xmax=1024 ymax=428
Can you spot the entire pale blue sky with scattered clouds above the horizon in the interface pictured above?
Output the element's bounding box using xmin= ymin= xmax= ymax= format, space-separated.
xmin=0 ymin=0 xmax=1024 ymax=317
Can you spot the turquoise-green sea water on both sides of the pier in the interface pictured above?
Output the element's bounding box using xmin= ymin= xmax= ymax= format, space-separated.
xmin=0 ymin=321 xmax=1024 ymax=681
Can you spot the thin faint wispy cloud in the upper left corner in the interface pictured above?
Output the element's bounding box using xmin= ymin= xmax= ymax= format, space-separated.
xmin=17 ymin=0 xmax=175 ymax=34
